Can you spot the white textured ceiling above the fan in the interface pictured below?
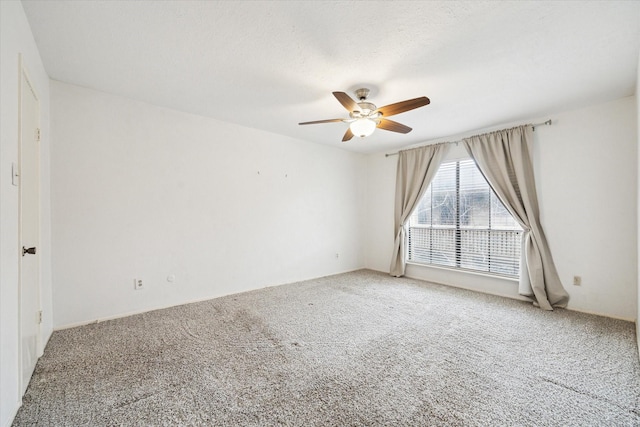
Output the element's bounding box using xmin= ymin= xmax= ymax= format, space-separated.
xmin=23 ymin=0 xmax=640 ymax=152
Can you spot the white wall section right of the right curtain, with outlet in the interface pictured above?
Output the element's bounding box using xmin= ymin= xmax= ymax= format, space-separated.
xmin=534 ymin=97 xmax=638 ymax=320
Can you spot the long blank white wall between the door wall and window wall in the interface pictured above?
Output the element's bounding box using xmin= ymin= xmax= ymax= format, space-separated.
xmin=51 ymin=81 xmax=365 ymax=328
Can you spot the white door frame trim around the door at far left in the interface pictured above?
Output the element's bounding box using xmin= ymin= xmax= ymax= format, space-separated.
xmin=16 ymin=53 xmax=43 ymax=393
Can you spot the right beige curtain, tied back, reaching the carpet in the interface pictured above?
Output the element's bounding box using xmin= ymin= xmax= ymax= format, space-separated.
xmin=463 ymin=125 xmax=569 ymax=310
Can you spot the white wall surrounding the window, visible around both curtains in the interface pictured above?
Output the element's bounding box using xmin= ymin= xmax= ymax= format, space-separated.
xmin=366 ymin=97 xmax=638 ymax=320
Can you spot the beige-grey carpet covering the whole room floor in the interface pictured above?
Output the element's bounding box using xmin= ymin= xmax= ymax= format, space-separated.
xmin=14 ymin=270 xmax=640 ymax=426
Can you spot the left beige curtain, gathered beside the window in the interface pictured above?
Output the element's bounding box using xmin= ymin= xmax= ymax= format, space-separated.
xmin=390 ymin=144 xmax=449 ymax=277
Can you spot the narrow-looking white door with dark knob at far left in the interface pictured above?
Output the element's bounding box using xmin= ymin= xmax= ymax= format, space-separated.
xmin=18 ymin=61 xmax=41 ymax=394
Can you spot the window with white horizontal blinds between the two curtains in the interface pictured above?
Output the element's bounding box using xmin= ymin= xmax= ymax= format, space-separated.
xmin=408 ymin=160 xmax=522 ymax=277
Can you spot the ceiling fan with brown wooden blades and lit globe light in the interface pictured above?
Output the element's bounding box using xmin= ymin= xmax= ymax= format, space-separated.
xmin=298 ymin=88 xmax=431 ymax=142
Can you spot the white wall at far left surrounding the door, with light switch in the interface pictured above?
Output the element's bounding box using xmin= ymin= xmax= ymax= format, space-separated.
xmin=0 ymin=1 xmax=52 ymax=426
